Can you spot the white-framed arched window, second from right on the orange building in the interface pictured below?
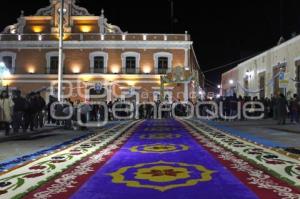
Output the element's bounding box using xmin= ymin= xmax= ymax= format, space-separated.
xmin=122 ymin=52 xmax=140 ymax=74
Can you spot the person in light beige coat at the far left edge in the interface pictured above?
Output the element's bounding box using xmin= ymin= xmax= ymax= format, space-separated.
xmin=0 ymin=91 xmax=14 ymax=136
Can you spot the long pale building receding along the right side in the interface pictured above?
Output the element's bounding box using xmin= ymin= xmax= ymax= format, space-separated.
xmin=222 ymin=36 xmax=300 ymax=98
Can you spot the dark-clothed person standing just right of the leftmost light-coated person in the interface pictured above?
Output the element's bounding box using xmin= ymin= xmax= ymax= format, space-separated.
xmin=12 ymin=90 xmax=28 ymax=133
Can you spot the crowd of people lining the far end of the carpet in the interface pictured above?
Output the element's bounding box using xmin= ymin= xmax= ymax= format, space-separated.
xmin=0 ymin=90 xmax=300 ymax=135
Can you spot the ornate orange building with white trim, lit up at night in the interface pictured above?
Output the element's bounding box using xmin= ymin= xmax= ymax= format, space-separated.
xmin=0 ymin=0 xmax=203 ymax=102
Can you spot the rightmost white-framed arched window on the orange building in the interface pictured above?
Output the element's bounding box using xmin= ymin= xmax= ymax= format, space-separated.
xmin=154 ymin=52 xmax=173 ymax=74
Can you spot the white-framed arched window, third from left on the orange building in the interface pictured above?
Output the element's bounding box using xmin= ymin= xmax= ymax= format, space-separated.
xmin=90 ymin=51 xmax=108 ymax=73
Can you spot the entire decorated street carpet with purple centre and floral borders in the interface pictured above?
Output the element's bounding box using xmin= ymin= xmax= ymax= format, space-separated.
xmin=0 ymin=120 xmax=300 ymax=199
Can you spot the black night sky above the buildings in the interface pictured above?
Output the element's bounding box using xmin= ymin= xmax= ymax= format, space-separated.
xmin=0 ymin=0 xmax=300 ymax=88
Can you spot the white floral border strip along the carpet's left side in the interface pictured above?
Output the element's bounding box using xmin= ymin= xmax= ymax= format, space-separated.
xmin=0 ymin=123 xmax=137 ymax=199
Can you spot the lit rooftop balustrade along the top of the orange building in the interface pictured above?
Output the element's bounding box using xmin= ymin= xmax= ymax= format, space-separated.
xmin=0 ymin=33 xmax=190 ymax=41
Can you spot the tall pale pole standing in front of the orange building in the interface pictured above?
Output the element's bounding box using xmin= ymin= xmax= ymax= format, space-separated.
xmin=57 ymin=0 xmax=65 ymax=102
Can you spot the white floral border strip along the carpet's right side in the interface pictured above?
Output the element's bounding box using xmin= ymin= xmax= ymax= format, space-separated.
xmin=189 ymin=121 xmax=300 ymax=187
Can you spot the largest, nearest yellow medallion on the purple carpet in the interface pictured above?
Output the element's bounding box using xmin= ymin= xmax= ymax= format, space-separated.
xmin=110 ymin=161 xmax=215 ymax=192
